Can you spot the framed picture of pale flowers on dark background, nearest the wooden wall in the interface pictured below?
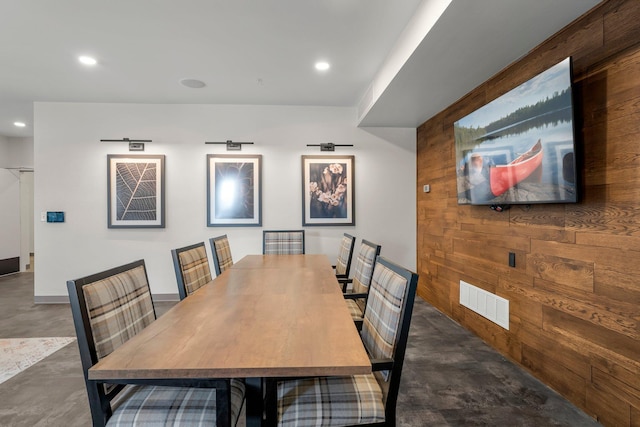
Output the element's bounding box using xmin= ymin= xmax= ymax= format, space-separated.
xmin=302 ymin=156 xmax=356 ymax=225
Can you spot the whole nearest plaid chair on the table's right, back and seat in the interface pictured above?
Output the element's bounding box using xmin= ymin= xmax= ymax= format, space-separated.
xmin=266 ymin=257 xmax=418 ymax=427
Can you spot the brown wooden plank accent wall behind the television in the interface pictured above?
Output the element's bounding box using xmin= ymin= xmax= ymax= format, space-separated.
xmin=416 ymin=0 xmax=640 ymax=426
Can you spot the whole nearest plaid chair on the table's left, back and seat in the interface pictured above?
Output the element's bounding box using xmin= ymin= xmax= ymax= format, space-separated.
xmin=67 ymin=260 xmax=245 ymax=426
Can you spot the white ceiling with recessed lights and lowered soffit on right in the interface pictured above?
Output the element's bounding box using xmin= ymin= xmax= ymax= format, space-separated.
xmin=0 ymin=0 xmax=600 ymax=137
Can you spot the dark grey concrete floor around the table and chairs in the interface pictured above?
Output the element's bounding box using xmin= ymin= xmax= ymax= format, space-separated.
xmin=0 ymin=273 xmax=600 ymax=427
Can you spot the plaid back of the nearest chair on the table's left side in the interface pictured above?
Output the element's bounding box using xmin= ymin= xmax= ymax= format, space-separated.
xmin=67 ymin=260 xmax=156 ymax=425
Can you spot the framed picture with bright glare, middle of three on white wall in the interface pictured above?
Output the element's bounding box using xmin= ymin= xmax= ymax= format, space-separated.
xmin=207 ymin=154 xmax=262 ymax=227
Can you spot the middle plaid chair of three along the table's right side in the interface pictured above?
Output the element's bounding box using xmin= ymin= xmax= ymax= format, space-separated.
xmin=338 ymin=239 xmax=381 ymax=328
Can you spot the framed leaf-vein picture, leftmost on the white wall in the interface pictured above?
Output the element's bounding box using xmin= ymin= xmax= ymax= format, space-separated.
xmin=107 ymin=154 xmax=164 ymax=228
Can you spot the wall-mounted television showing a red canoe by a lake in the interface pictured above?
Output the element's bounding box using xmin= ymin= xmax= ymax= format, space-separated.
xmin=454 ymin=57 xmax=578 ymax=205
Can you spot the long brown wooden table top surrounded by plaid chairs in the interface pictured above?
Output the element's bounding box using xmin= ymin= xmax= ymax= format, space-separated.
xmin=89 ymin=255 xmax=371 ymax=380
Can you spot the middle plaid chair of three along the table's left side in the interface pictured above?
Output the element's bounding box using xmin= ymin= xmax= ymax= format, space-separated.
xmin=171 ymin=242 xmax=211 ymax=300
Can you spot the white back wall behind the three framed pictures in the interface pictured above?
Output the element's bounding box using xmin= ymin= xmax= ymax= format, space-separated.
xmin=34 ymin=103 xmax=416 ymax=302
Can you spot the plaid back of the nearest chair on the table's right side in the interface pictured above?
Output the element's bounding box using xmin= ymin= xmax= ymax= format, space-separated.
xmin=361 ymin=256 xmax=418 ymax=420
